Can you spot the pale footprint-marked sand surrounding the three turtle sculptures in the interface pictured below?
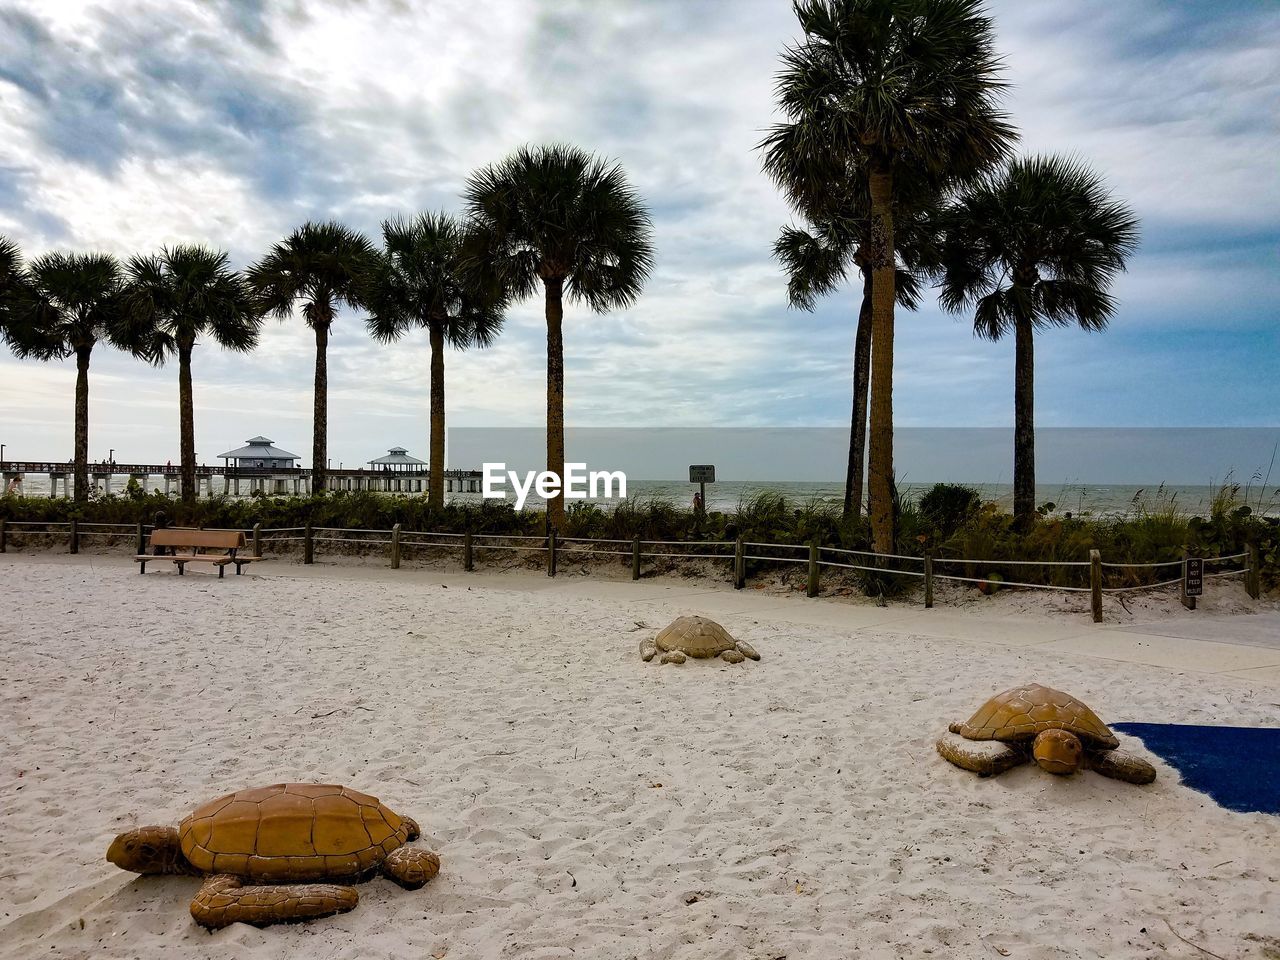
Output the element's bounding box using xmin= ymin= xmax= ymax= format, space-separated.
xmin=0 ymin=556 xmax=1280 ymax=960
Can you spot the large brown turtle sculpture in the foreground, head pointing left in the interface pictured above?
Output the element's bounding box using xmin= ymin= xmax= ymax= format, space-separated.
xmin=106 ymin=783 xmax=440 ymax=929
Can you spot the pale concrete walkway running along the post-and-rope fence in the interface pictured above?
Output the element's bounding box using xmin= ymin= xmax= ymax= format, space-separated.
xmin=10 ymin=553 xmax=1280 ymax=687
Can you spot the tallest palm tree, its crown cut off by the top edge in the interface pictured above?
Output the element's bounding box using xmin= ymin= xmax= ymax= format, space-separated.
xmin=777 ymin=0 xmax=1015 ymax=553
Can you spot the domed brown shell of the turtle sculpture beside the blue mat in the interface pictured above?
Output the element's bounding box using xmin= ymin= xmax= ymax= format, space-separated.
xmin=951 ymin=684 xmax=1120 ymax=750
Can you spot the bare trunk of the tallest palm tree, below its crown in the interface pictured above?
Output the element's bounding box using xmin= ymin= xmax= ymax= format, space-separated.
xmin=867 ymin=166 xmax=896 ymax=553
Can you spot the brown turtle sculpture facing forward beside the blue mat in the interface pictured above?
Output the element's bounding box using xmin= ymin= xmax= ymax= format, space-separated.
xmin=938 ymin=684 xmax=1156 ymax=783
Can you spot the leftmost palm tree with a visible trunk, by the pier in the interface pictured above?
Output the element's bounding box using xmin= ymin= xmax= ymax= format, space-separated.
xmin=6 ymin=253 xmax=146 ymax=500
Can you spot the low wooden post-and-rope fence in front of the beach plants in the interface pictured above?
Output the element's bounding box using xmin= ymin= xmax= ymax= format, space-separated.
xmin=0 ymin=520 xmax=1261 ymax=622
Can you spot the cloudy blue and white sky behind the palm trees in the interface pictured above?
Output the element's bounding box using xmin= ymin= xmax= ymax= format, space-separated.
xmin=0 ymin=0 xmax=1280 ymax=466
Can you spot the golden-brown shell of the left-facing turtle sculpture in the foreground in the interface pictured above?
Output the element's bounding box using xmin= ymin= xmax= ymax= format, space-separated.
xmin=178 ymin=783 xmax=412 ymax=883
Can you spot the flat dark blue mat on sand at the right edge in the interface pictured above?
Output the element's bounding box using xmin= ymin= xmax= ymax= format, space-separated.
xmin=1111 ymin=723 xmax=1280 ymax=815
